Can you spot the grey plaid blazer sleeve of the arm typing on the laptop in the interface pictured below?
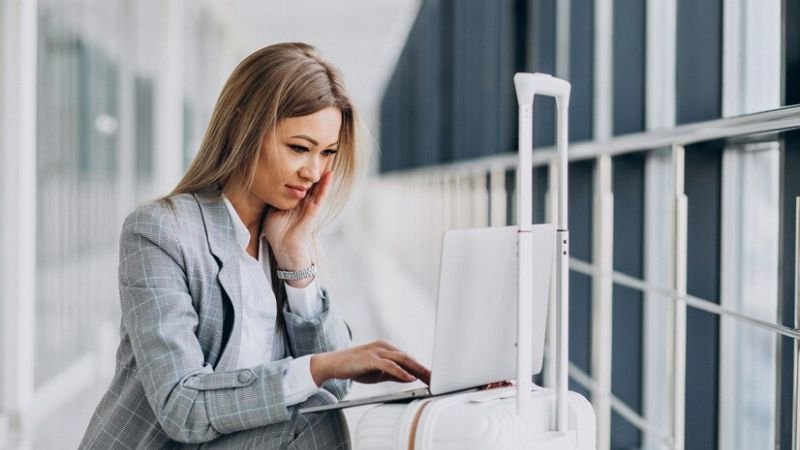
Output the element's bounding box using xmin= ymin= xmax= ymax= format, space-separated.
xmin=119 ymin=203 xmax=291 ymax=443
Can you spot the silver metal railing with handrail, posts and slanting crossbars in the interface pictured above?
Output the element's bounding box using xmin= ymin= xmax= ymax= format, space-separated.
xmin=375 ymin=106 xmax=800 ymax=450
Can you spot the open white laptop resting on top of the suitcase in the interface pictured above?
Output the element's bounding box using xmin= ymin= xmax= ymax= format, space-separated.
xmin=299 ymin=224 xmax=555 ymax=413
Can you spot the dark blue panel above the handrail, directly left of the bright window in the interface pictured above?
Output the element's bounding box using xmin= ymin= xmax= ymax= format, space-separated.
xmin=675 ymin=0 xmax=722 ymax=124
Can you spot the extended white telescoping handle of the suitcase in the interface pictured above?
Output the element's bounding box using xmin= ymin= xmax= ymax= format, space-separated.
xmin=514 ymin=73 xmax=570 ymax=432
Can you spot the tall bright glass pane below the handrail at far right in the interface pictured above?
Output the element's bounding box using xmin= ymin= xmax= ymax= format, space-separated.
xmin=719 ymin=143 xmax=780 ymax=449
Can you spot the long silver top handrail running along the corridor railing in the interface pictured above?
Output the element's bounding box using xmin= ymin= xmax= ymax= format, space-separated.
xmin=381 ymin=105 xmax=800 ymax=178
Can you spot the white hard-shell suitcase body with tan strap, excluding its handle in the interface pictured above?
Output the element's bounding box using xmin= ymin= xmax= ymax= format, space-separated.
xmin=353 ymin=387 xmax=595 ymax=450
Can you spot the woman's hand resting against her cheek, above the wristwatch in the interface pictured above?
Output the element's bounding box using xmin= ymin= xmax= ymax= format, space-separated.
xmin=263 ymin=171 xmax=333 ymax=287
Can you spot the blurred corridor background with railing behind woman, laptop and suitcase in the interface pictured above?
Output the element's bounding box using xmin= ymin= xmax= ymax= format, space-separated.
xmin=0 ymin=0 xmax=800 ymax=450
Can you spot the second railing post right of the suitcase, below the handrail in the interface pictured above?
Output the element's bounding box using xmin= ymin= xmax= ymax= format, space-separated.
xmin=671 ymin=144 xmax=687 ymax=450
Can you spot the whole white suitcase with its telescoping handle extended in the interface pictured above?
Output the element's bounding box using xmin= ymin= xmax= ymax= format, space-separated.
xmin=354 ymin=73 xmax=595 ymax=450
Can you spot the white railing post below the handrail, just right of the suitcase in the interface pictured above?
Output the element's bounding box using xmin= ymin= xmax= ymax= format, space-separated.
xmin=592 ymin=155 xmax=614 ymax=450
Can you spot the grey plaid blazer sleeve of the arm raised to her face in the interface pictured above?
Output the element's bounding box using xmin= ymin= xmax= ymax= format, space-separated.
xmin=283 ymin=289 xmax=352 ymax=400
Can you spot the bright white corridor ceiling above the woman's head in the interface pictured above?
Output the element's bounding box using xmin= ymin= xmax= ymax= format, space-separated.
xmin=229 ymin=0 xmax=420 ymax=135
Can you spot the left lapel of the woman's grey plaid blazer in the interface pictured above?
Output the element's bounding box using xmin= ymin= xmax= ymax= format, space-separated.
xmin=194 ymin=191 xmax=242 ymax=368
